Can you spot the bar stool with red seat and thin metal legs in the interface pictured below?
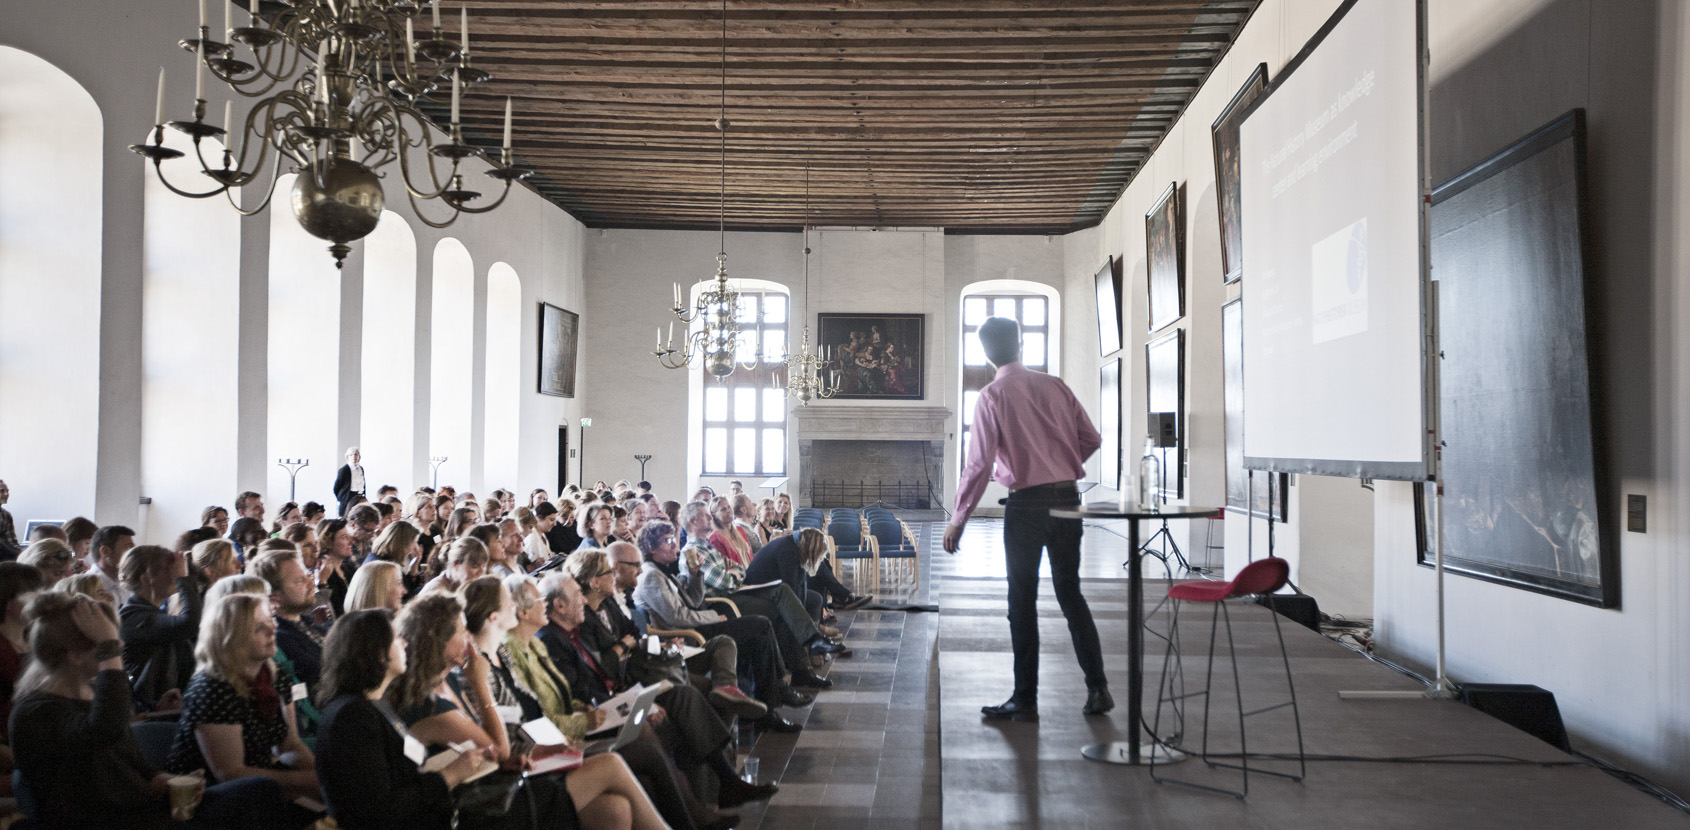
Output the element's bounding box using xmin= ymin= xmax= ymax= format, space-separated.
xmin=1149 ymin=556 xmax=1308 ymax=798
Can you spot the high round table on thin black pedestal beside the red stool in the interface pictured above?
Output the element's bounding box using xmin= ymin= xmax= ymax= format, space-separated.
xmin=1051 ymin=502 xmax=1222 ymax=766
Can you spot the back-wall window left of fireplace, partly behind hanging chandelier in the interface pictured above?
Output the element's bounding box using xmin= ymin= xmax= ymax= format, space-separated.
xmin=700 ymin=291 xmax=788 ymax=475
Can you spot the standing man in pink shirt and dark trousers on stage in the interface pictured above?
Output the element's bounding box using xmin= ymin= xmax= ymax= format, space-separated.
xmin=945 ymin=318 xmax=1115 ymax=720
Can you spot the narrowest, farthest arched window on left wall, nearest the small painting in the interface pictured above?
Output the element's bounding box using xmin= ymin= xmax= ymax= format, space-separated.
xmin=482 ymin=262 xmax=522 ymax=489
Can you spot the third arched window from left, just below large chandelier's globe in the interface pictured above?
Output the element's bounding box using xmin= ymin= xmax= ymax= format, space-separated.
xmin=263 ymin=174 xmax=345 ymax=507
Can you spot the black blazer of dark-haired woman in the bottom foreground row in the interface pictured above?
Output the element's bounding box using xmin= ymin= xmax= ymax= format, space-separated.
xmin=316 ymin=695 xmax=453 ymax=830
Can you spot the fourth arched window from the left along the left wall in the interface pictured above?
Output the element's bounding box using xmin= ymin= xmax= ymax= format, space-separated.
xmin=358 ymin=210 xmax=423 ymax=495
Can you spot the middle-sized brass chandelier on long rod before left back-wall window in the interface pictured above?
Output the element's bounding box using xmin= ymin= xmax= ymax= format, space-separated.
xmin=652 ymin=0 xmax=762 ymax=377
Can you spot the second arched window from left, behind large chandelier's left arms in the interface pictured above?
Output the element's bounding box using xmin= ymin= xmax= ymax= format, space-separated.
xmin=137 ymin=130 xmax=240 ymax=541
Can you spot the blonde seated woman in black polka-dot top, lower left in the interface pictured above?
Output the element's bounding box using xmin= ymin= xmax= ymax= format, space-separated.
xmin=164 ymin=593 xmax=318 ymax=808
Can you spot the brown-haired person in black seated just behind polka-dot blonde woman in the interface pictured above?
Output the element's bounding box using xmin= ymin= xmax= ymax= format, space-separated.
xmin=118 ymin=544 xmax=204 ymax=706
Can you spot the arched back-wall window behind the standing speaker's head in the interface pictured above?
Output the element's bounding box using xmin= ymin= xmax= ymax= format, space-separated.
xmin=957 ymin=279 xmax=1061 ymax=468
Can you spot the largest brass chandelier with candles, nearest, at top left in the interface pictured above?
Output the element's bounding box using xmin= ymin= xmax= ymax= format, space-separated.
xmin=130 ymin=0 xmax=532 ymax=267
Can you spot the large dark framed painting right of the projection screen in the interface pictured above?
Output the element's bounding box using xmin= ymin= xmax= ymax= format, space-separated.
xmin=1418 ymin=110 xmax=1619 ymax=607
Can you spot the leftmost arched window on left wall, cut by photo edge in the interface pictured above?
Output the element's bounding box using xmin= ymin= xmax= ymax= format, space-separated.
xmin=0 ymin=46 xmax=105 ymax=527
